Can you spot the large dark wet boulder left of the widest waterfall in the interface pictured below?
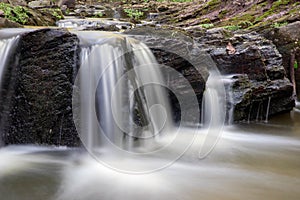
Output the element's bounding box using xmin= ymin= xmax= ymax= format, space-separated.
xmin=0 ymin=29 xmax=79 ymax=146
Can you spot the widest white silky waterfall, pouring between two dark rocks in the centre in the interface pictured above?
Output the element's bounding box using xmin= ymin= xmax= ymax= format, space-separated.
xmin=73 ymin=32 xmax=172 ymax=150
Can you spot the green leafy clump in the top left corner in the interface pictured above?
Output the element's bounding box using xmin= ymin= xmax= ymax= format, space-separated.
xmin=0 ymin=3 xmax=29 ymax=24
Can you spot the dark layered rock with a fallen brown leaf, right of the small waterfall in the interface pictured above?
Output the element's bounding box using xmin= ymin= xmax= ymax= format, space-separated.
xmin=188 ymin=28 xmax=295 ymax=121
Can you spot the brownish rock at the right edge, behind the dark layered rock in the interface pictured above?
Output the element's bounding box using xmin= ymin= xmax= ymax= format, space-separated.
xmin=262 ymin=21 xmax=300 ymax=100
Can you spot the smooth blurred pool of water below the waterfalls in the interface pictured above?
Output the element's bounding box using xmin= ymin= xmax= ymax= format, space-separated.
xmin=0 ymin=111 xmax=300 ymax=200
